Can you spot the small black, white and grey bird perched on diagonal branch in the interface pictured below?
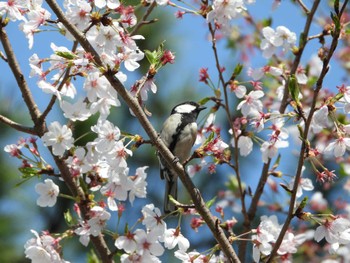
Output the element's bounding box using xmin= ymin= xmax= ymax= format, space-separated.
xmin=159 ymin=101 xmax=206 ymax=213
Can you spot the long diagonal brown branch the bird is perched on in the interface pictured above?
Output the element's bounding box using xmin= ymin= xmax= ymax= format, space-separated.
xmin=46 ymin=0 xmax=240 ymax=262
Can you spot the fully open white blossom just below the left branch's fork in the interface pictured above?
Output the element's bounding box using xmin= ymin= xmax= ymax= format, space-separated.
xmin=41 ymin=121 xmax=74 ymax=156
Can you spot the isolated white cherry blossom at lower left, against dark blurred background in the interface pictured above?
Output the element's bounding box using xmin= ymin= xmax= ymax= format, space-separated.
xmin=35 ymin=179 xmax=60 ymax=207
